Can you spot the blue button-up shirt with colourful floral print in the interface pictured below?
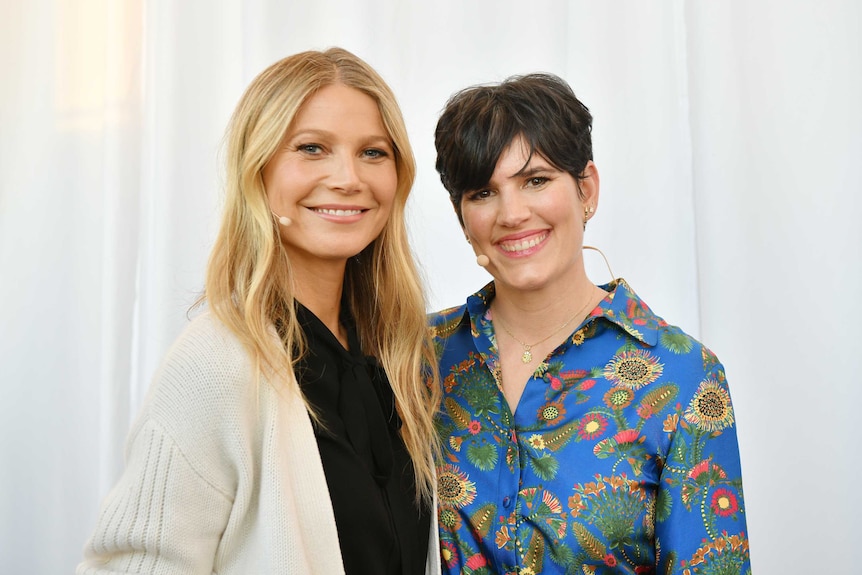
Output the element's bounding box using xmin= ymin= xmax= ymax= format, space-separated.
xmin=431 ymin=279 xmax=751 ymax=575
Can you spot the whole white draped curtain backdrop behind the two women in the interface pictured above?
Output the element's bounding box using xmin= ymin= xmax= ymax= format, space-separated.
xmin=0 ymin=0 xmax=862 ymax=575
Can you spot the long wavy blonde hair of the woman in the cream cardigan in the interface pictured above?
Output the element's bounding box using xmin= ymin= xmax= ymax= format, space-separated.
xmin=204 ymin=48 xmax=440 ymax=502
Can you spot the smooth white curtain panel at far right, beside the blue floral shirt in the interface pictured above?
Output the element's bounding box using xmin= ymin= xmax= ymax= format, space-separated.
xmin=689 ymin=1 xmax=862 ymax=574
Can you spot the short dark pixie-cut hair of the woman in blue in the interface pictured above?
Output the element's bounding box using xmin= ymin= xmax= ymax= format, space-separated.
xmin=434 ymin=74 xmax=593 ymax=225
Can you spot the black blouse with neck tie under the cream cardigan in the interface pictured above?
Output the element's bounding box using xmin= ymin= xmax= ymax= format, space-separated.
xmin=296 ymin=303 xmax=431 ymax=575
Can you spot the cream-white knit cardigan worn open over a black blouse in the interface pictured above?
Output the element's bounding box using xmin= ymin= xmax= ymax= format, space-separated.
xmin=76 ymin=313 xmax=440 ymax=575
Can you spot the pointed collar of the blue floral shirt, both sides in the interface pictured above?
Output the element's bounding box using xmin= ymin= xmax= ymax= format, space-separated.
xmin=462 ymin=278 xmax=667 ymax=347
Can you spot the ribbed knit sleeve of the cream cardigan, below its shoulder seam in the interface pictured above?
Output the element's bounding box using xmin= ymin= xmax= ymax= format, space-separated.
xmin=77 ymin=421 xmax=232 ymax=575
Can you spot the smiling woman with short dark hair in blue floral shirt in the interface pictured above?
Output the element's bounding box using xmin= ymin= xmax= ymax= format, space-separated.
xmin=433 ymin=75 xmax=750 ymax=575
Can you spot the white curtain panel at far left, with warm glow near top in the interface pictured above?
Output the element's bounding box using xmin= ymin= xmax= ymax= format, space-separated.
xmin=0 ymin=1 xmax=141 ymax=573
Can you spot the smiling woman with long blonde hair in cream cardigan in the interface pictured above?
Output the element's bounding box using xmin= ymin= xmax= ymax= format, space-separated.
xmin=77 ymin=49 xmax=439 ymax=575
